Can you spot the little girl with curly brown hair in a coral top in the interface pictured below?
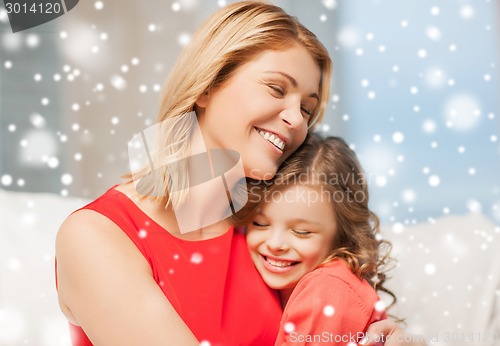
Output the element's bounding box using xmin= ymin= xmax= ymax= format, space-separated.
xmin=247 ymin=135 xmax=390 ymax=345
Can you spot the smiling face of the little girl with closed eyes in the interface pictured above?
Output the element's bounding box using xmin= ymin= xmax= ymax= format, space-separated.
xmin=247 ymin=185 xmax=337 ymax=291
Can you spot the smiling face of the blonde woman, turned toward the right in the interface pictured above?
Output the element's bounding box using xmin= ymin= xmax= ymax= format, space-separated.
xmin=197 ymin=44 xmax=321 ymax=179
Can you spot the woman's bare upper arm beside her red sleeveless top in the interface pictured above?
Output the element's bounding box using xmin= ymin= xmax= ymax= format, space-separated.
xmin=56 ymin=210 xmax=199 ymax=345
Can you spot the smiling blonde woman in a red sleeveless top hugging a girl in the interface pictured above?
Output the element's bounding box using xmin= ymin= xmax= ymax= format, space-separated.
xmin=56 ymin=2 xmax=428 ymax=345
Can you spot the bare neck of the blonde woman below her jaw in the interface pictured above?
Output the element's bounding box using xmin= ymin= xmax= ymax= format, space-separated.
xmin=169 ymin=120 xmax=248 ymax=234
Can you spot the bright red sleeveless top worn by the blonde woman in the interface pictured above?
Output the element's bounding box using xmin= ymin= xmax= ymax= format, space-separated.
xmin=57 ymin=187 xmax=282 ymax=346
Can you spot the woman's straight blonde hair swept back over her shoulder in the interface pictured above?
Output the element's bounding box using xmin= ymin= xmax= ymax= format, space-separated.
xmin=125 ymin=1 xmax=331 ymax=207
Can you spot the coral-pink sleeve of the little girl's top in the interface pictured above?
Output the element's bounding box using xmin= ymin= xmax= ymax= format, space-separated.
xmin=276 ymin=270 xmax=378 ymax=345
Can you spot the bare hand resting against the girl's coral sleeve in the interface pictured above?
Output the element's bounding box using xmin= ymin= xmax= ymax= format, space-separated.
xmin=359 ymin=320 xmax=427 ymax=346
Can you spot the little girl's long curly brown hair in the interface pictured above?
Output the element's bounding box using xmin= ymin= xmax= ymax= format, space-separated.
xmin=246 ymin=133 xmax=396 ymax=305
